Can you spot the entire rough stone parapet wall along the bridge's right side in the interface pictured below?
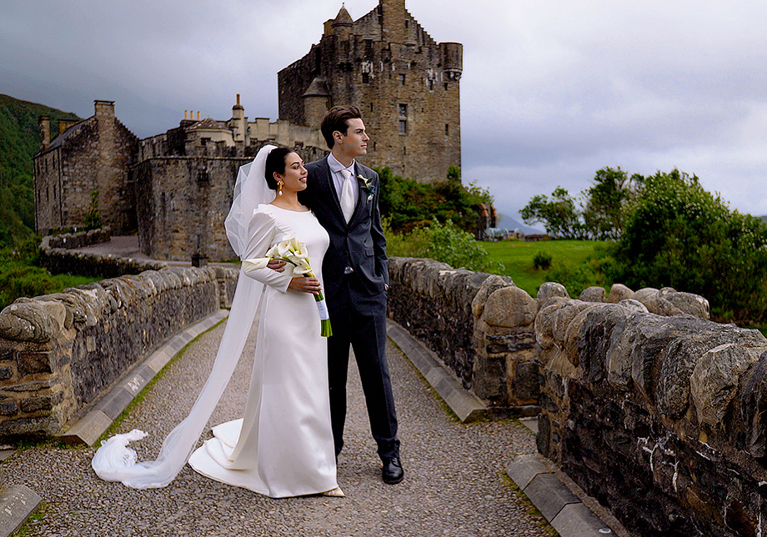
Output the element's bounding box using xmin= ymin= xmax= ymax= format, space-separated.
xmin=389 ymin=258 xmax=767 ymax=537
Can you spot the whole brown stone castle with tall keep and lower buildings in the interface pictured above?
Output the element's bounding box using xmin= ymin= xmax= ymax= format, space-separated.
xmin=34 ymin=0 xmax=463 ymax=260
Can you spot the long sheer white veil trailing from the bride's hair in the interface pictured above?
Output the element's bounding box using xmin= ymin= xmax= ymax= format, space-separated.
xmin=91 ymin=145 xmax=275 ymax=489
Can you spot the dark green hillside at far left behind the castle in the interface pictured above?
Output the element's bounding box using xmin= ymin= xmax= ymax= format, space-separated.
xmin=0 ymin=94 xmax=80 ymax=247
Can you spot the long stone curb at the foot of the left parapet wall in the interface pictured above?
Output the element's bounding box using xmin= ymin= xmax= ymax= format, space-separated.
xmin=58 ymin=310 xmax=229 ymax=446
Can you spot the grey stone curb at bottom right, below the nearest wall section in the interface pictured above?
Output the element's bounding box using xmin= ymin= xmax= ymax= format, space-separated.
xmin=506 ymin=454 xmax=616 ymax=537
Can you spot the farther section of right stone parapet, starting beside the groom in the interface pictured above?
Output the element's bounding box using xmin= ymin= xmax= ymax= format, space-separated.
xmin=389 ymin=257 xmax=708 ymax=416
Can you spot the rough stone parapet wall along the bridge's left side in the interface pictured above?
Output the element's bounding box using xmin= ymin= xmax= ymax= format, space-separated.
xmin=0 ymin=267 xmax=239 ymax=440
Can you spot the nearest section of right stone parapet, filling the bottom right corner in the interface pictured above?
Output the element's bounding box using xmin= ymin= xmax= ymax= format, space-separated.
xmin=535 ymin=289 xmax=767 ymax=537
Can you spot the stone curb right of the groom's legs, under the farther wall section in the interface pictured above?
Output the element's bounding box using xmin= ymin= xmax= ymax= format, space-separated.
xmin=386 ymin=319 xmax=490 ymax=423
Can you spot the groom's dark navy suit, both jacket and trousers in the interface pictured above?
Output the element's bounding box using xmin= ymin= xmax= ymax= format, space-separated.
xmin=299 ymin=154 xmax=399 ymax=459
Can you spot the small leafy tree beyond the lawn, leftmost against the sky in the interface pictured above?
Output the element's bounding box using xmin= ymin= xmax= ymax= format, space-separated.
xmin=519 ymin=186 xmax=585 ymax=239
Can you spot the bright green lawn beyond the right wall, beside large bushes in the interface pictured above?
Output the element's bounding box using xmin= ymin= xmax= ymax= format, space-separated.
xmin=481 ymin=240 xmax=607 ymax=296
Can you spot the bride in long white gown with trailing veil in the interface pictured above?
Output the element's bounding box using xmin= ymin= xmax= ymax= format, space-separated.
xmin=92 ymin=146 xmax=343 ymax=498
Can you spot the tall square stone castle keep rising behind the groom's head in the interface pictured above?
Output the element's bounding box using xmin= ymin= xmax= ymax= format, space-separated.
xmin=278 ymin=0 xmax=463 ymax=182
